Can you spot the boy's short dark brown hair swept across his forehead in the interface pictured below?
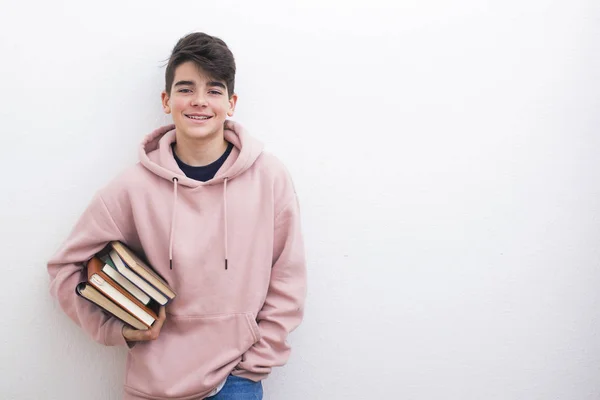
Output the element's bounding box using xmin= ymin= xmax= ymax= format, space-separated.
xmin=165 ymin=32 xmax=235 ymax=97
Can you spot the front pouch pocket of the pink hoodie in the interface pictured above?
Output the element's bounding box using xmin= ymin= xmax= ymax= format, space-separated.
xmin=125 ymin=313 xmax=261 ymax=400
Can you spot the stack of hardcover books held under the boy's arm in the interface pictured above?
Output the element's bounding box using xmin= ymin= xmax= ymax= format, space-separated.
xmin=76 ymin=241 xmax=175 ymax=330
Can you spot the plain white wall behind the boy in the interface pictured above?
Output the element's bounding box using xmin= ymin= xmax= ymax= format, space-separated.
xmin=0 ymin=0 xmax=600 ymax=400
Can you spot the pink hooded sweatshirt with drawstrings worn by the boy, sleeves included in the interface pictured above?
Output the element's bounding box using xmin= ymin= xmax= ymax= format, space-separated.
xmin=48 ymin=121 xmax=306 ymax=399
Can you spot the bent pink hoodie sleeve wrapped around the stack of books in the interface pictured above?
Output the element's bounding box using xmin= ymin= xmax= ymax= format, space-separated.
xmin=48 ymin=193 xmax=126 ymax=346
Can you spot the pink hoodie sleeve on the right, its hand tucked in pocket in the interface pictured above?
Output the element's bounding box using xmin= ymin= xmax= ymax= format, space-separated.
xmin=233 ymin=195 xmax=306 ymax=381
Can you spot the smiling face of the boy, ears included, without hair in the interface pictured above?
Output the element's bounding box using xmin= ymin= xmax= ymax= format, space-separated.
xmin=162 ymin=61 xmax=237 ymax=141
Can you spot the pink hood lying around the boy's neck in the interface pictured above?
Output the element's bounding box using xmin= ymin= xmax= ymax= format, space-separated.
xmin=139 ymin=120 xmax=264 ymax=188
